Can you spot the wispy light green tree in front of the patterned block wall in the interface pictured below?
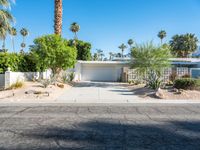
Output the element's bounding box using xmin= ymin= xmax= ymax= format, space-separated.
xmin=131 ymin=42 xmax=171 ymax=89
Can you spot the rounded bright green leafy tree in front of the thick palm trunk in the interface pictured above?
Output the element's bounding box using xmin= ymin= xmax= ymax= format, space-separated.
xmin=31 ymin=35 xmax=77 ymax=75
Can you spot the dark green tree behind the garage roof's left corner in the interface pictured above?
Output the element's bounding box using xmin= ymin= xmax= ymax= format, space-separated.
xmin=68 ymin=40 xmax=92 ymax=61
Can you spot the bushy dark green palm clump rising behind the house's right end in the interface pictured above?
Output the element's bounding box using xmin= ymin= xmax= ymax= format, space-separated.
xmin=170 ymin=33 xmax=198 ymax=57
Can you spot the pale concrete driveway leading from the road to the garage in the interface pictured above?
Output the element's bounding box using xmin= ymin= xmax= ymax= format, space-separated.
xmin=58 ymin=82 xmax=140 ymax=103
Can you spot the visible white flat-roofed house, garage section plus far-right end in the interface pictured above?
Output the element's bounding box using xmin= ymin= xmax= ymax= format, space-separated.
xmin=75 ymin=58 xmax=200 ymax=82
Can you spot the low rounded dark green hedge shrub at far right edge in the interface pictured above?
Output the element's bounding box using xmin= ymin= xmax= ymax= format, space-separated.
xmin=174 ymin=78 xmax=198 ymax=90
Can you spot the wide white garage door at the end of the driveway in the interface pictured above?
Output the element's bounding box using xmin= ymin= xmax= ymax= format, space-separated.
xmin=82 ymin=65 xmax=122 ymax=82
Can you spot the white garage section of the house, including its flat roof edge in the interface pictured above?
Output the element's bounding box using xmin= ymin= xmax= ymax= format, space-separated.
xmin=75 ymin=61 xmax=129 ymax=82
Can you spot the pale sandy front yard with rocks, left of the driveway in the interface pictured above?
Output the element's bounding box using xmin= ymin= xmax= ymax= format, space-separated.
xmin=0 ymin=82 xmax=71 ymax=103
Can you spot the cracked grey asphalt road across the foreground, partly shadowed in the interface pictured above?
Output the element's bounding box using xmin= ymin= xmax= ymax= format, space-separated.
xmin=0 ymin=104 xmax=200 ymax=150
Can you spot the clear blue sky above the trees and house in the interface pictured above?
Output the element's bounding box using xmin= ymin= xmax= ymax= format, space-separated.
xmin=2 ymin=0 xmax=200 ymax=56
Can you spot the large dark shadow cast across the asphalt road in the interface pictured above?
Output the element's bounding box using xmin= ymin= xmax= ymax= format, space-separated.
xmin=1 ymin=121 xmax=200 ymax=150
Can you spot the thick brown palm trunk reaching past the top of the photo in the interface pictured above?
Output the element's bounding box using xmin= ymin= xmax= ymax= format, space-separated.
xmin=54 ymin=0 xmax=63 ymax=35
